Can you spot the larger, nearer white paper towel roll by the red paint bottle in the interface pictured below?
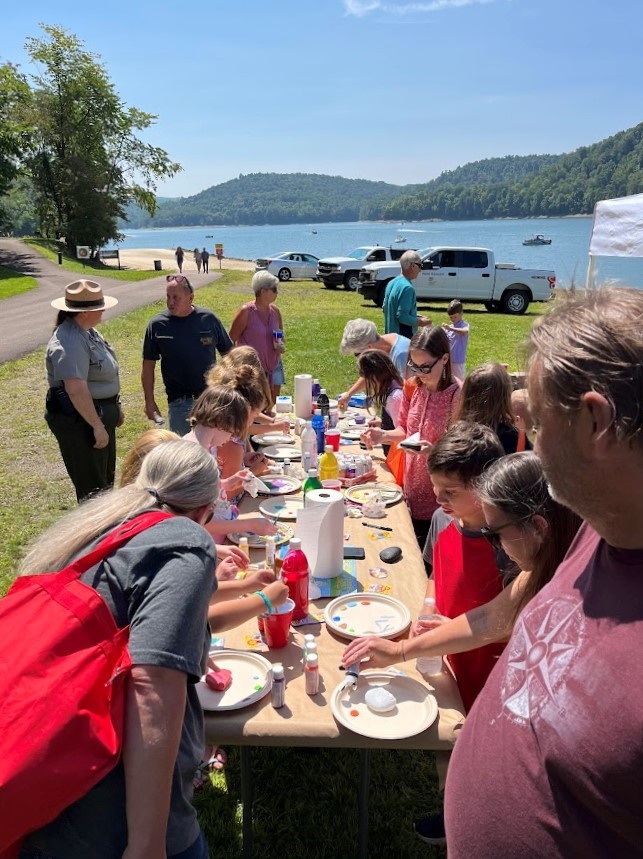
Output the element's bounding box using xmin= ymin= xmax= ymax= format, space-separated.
xmin=296 ymin=489 xmax=344 ymax=579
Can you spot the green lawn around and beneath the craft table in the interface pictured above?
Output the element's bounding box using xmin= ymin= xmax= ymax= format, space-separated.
xmin=0 ymin=272 xmax=539 ymax=859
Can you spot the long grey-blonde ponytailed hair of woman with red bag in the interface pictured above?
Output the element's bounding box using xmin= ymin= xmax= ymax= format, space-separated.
xmin=18 ymin=439 xmax=219 ymax=576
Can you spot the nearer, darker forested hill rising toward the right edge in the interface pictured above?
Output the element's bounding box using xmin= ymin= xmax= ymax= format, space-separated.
xmin=378 ymin=123 xmax=643 ymax=220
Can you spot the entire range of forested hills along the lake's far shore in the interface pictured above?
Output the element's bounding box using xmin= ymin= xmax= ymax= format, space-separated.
xmin=121 ymin=123 xmax=643 ymax=227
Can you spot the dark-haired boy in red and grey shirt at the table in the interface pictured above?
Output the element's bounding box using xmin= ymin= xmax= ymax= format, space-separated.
xmin=424 ymin=421 xmax=510 ymax=710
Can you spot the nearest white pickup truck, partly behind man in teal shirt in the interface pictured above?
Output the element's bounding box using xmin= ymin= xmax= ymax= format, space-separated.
xmin=359 ymin=247 xmax=556 ymax=316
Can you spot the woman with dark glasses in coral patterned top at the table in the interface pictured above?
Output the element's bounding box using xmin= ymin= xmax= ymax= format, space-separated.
xmin=362 ymin=328 xmax=460 ymax=548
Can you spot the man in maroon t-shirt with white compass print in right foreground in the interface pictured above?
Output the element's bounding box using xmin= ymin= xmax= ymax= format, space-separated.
xmin=445 ymin=288 xmax=643 ymax=859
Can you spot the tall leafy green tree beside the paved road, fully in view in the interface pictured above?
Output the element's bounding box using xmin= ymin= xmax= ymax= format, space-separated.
xmin=26 ymin=24 xmax=181 ymax=253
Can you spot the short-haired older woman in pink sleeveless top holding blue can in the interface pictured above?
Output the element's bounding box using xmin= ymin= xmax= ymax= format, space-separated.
xmin=230 ymin=271 xmax=286 ymax=403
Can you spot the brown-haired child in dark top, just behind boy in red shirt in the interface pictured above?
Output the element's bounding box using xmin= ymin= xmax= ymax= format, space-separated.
xmin=455 ymin=362 xmax=531 ymax=453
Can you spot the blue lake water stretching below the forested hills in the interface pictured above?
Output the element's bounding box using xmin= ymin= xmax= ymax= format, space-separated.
xmin=121 ymin=217 xmax=643 ymax=288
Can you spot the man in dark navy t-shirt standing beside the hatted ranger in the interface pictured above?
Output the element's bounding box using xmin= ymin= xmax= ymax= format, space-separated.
xmin=141 ymin=274 xmax=232 ymax=436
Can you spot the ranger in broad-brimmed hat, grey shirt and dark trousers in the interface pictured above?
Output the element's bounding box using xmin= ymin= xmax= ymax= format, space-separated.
xmin=45 ymin=280 xmax=124 ymax=501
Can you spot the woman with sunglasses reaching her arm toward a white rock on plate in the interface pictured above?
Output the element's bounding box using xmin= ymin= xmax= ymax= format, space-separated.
xmin=342 ymin=452 xmax=581 ymax=844
